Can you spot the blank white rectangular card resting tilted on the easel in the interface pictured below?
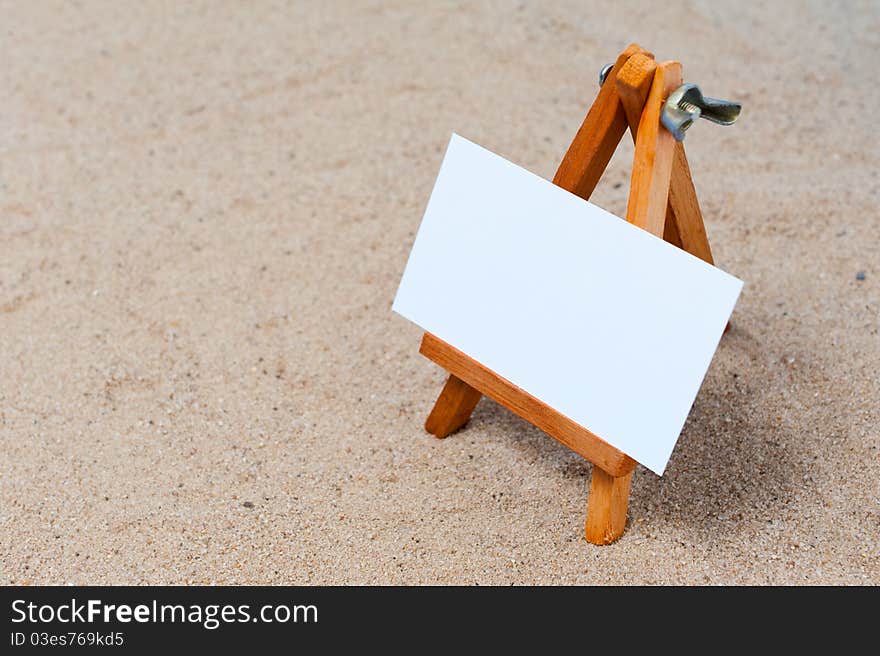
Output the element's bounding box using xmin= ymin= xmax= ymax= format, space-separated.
xmin=393 ymin=135 xmax=742 ymax=474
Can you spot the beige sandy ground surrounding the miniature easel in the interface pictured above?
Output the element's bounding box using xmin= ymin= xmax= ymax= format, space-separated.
xmin=0 ymin=0 xmax=880 ymax=584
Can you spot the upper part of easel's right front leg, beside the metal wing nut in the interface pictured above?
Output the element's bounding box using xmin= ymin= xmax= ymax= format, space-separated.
xmin=626 ymin=62 xmax=681 ymax=238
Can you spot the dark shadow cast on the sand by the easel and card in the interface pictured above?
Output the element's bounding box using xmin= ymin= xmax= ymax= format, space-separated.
xmin=465 ymin=328 xmax=805 ymax=534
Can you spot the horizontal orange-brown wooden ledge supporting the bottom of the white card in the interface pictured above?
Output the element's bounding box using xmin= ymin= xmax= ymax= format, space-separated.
xmin=419 ymin=333 xmax=636 ymax=476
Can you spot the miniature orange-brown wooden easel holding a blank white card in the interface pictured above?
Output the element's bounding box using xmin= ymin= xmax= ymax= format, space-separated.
xmin=419 ymin=44 xmax=713 ymax=544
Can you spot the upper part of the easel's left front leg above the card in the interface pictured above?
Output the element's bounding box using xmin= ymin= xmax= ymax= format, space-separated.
xmin=553 ymin=43 xmax=650 ymax=199
